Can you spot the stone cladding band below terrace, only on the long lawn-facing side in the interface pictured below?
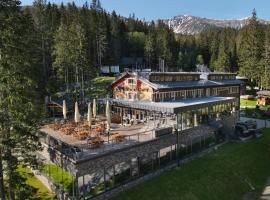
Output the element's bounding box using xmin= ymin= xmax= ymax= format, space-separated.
xmin=76 ymin=117 xmax=235 ymax=176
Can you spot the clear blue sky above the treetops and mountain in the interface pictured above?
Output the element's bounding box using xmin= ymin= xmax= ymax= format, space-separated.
xmin=21 ymin=0 xmax=270 ymax=20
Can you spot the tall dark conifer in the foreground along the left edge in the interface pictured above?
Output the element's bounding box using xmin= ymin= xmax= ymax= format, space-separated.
xmin=0 ymin=0 xmax=41 ymax=200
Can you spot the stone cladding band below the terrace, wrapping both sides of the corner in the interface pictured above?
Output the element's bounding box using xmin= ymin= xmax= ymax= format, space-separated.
xmin=40 ymin=117 xmax=236 ymax=177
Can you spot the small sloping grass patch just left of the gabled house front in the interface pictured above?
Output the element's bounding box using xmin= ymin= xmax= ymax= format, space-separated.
xmin=87 ymin=76 xmax=115 ymax=98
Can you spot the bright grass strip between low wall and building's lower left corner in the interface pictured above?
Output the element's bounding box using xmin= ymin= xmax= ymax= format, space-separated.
xmin=41 ymin=164 xmax=72 ymax=191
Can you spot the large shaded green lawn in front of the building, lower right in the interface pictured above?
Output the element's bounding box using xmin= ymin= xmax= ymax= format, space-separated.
xmin=114 ymin=129 xmax=270 ymax=200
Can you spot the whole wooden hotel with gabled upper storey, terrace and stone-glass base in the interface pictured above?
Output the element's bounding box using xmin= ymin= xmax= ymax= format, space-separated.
xmin=39 ymin=72 xmax=242 ymax=200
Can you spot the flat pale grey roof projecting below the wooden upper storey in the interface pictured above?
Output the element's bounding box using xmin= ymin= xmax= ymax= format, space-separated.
xmin=100 ymin=97 xmax=236 ymax=114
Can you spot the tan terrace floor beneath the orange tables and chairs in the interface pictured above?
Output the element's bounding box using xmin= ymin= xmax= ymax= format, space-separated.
xmin=40 ymin=121 xmax=165 ymax=159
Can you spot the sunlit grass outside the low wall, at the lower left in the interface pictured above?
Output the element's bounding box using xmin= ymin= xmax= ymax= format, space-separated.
xmin=18 ymin=166 xmax=55 ymax=200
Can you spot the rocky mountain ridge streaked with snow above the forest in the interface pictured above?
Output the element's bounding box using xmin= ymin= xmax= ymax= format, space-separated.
xmin=164 ymin=15 xmax=269 ymax=35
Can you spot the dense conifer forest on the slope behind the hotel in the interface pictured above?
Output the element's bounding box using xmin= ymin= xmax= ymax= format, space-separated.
xmin=3 ymin=0 xmax=270 ymax=94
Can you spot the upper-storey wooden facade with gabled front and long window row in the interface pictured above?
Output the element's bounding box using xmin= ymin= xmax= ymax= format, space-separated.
xmin=112 ymin=73 xmax=240 ymax=102
